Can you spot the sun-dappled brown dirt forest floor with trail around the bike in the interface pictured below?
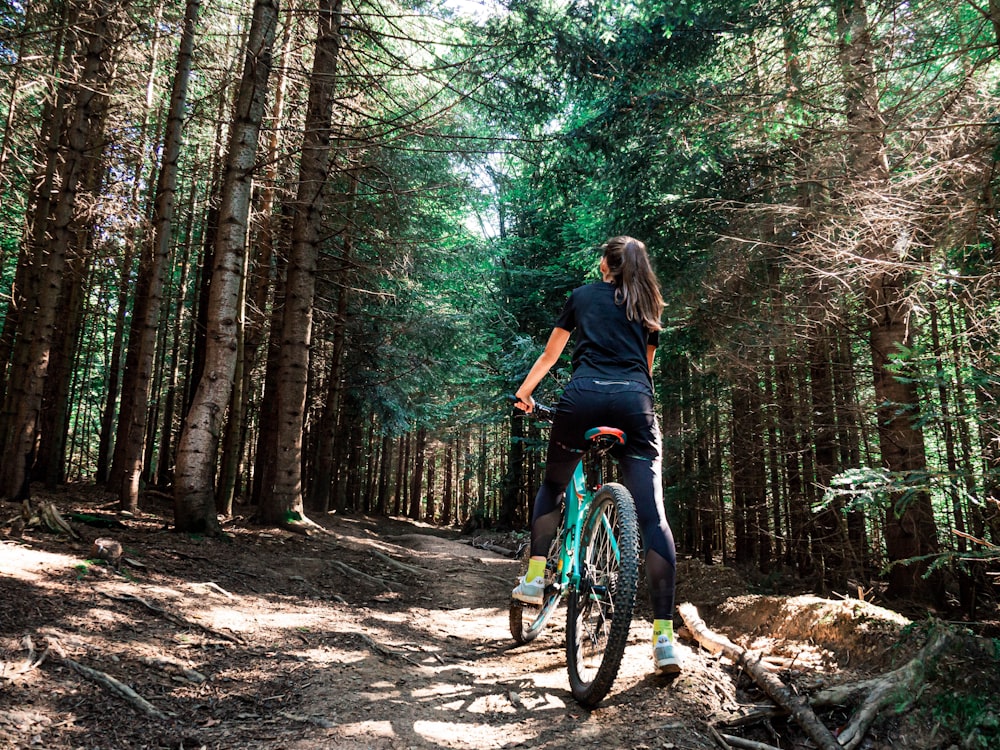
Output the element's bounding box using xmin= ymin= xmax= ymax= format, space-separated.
xmin=0 ymin=487 xmax=1000 ymax=750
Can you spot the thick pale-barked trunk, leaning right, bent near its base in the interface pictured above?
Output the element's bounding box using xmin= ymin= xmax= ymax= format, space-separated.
xmin=174 ymin=0 xmax=278 ymax=534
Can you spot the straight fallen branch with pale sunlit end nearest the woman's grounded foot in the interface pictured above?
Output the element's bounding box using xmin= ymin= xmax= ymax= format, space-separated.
xmin=677 ymin=604 xmax=841 ymax=750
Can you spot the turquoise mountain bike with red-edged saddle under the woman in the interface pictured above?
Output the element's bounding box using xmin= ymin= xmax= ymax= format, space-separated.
xmin=510 ymin=404 xmax=639 ymax=708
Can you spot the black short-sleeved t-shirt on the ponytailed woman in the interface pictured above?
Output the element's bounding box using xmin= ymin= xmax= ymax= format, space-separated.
xmin=556 ymin=281 xmax=659 ymax=383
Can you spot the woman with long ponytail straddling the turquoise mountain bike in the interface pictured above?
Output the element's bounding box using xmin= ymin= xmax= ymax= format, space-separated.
xmin=511 ymin=237 xmax=681 ymax=673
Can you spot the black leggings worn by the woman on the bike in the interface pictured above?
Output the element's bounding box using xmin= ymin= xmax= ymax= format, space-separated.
xmin=531 ymin=378 xmax=677 ymax=620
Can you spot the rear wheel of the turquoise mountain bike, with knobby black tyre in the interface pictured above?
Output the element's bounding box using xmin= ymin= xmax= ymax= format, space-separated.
xmin=566 ymin=484 xmax=639 ymax=708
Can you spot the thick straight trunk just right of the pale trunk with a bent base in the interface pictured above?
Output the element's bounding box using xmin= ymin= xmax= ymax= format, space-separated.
xmin=258 ymin=0 xmax=342 ymax=523
